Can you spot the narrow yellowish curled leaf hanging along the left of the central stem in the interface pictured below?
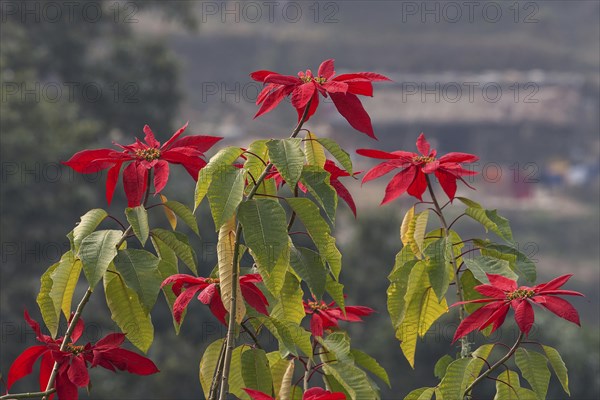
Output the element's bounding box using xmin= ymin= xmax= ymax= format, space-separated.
xmin=217 ymin=217 xmax=246 ymax=324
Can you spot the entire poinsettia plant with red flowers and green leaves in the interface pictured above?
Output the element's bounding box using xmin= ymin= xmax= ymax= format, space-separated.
xmin=0 ymin=60 xmax=580 ymax=400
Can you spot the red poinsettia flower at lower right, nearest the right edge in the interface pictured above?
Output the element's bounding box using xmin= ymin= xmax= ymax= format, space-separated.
xmin=452 ymin=274 xmax=583 ymax=343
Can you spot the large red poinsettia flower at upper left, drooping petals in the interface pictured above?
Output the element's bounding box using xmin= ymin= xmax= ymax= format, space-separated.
xmin=64 ymin=123 xmax=222 ymax=207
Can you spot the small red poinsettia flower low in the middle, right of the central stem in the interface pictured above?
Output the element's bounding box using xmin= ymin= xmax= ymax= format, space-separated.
xmin=303 ymin=299 xmax=375 ymax=337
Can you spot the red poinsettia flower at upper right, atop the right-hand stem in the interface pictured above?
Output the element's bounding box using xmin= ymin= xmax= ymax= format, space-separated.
xmin=356 ymin=133 xmax=479 ymax=204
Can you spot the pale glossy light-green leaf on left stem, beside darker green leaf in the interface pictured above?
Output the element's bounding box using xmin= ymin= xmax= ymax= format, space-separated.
xmin=78 ymin=230 xmax=123 ymax=289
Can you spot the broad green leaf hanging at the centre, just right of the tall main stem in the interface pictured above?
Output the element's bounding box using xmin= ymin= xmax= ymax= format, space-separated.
xmin=238 ymin=199 xmax=289 ymax=271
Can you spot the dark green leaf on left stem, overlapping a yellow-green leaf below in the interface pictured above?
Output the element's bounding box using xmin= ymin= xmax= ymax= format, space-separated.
xmin=113 ymin=249 xmax=163 ymax=314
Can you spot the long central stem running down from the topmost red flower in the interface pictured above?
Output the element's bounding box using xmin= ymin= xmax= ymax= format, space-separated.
xmin=219 ymin=100 xmax=312 ymax=400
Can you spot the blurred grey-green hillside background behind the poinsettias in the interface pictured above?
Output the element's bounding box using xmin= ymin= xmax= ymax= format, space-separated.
xmin=0 ymin=0 xmax=600 ymax=400
